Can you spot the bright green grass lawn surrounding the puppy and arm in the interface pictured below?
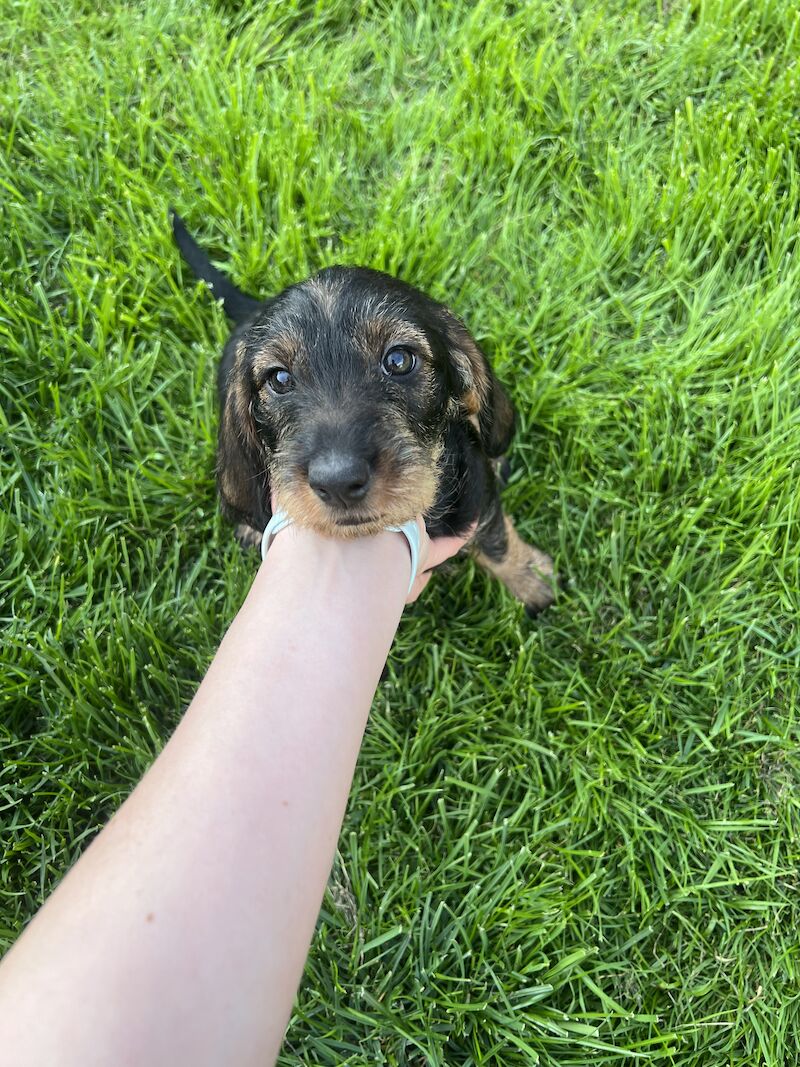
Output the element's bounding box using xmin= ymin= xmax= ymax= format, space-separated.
xmin=0 ymin=0 xmax=800 ymax=1067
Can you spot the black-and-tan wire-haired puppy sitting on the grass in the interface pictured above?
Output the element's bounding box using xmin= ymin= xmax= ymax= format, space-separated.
xmin=173 ymin=214 xmax=553 ymax=614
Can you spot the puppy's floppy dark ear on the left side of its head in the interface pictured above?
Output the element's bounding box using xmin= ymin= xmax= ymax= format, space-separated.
xmin=217 ymin=350 xmax=272 ymax=530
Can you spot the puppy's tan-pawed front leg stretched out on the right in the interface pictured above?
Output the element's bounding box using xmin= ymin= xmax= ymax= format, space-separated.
xmin=474 ymin=497 xmax=556 ymax=616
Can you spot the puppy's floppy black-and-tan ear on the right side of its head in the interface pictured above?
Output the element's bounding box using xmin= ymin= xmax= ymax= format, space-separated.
xmin=445 ymin=309 xmax=516 ymax=458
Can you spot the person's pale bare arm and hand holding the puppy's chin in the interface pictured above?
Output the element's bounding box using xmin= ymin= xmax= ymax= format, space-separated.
xmin=0 ymin=518 xmax=464 ymax=1067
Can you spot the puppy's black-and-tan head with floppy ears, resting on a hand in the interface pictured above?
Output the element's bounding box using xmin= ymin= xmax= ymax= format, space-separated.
xmin=219 ymin=267 xmax=514 ymax=537
